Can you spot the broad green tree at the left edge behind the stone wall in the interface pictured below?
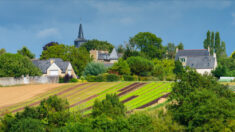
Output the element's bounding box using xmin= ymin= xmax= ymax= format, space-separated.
xmin=0 ymin=53 xmax=41 ymax=77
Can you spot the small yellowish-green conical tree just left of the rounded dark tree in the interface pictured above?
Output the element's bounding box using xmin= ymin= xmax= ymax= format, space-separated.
xmin=109 ymin=59 xmax=131 ymax=75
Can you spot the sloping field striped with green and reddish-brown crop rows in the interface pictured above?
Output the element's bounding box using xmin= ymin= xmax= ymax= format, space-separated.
xmin=1 ymin=82 xmax=172 ymax=114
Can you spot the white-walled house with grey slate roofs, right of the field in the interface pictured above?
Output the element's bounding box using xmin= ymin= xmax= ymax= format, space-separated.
xmin=175 ymin=48 xmax=217 ymax=74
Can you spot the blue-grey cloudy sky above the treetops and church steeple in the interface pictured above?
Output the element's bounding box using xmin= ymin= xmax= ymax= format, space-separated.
xmin=0 ymin=0 xmax=235 ymax=57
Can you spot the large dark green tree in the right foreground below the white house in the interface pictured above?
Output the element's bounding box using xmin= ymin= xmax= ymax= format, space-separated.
xmin=168 ymin=69 xmax=235 ymax=131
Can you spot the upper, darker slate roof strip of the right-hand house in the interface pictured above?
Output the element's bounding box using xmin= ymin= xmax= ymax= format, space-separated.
xmin=175 ymin=49 xmax=210 ymax=60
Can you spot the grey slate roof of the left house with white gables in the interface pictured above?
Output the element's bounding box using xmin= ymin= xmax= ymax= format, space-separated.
xmin=32 ymin=58 xmax=70 ymax=74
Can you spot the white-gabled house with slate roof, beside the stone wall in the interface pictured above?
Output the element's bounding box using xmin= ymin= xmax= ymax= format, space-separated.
xmin=32 ymin=58 xmax=77 ymax=78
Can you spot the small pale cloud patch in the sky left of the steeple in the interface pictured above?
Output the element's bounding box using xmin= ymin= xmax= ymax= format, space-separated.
xmin=37 ymin=28 xmax=59 ymax=38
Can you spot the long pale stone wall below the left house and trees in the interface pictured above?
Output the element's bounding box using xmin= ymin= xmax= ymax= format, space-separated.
xmin=0 ymin=76 xmax=59 ymax=86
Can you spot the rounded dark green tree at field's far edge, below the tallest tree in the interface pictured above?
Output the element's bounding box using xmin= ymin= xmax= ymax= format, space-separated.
xmin=127 ymin=56 xmax=154 ymax=76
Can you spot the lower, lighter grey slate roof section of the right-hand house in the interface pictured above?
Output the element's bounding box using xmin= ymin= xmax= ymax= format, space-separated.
xmin=186 ymin=56 xmax=216 ymax=69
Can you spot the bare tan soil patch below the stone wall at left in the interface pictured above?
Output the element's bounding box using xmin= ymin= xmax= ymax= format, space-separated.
xmin=0 ymin=84 xmax=66 ymax=108
